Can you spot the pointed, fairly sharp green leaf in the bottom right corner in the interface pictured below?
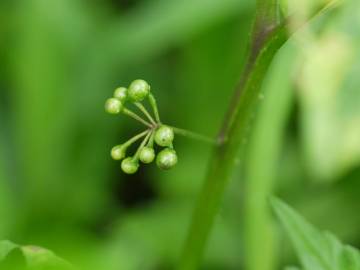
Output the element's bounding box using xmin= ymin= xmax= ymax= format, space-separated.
xmin=272 ymin=199 xmax=360 ymax=270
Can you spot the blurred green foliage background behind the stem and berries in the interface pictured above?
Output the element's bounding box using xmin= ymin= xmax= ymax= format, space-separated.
xmin=0 ymin=0 xmax=360 ymax=270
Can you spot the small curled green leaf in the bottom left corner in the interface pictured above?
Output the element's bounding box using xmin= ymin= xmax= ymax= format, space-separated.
xmin=0 ymin=240 xmax=74 ymax=270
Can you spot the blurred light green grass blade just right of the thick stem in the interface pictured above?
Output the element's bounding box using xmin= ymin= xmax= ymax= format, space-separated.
xmin=245 ymin=40 xmax=297 ymax=270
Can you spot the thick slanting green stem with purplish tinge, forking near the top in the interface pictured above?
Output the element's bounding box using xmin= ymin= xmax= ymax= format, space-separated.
xmin=178 ymin=0 xmax=340 ymax=270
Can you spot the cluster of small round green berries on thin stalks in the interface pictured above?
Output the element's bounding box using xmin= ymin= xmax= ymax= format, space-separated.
xmin=105 ymin=80 xmax=181 ymax=174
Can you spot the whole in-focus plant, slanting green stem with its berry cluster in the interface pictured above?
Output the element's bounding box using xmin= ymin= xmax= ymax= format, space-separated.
xmin=100 ymin=0 xmax=344 ymax=270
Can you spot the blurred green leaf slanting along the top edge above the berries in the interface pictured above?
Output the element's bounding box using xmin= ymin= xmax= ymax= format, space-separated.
xmin=100 ymin=0 xmax=251 ymax=65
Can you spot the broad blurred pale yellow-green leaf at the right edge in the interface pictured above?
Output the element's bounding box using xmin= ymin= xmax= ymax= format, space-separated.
xmin=298 ymin=1 xmax=360 ymax=180
